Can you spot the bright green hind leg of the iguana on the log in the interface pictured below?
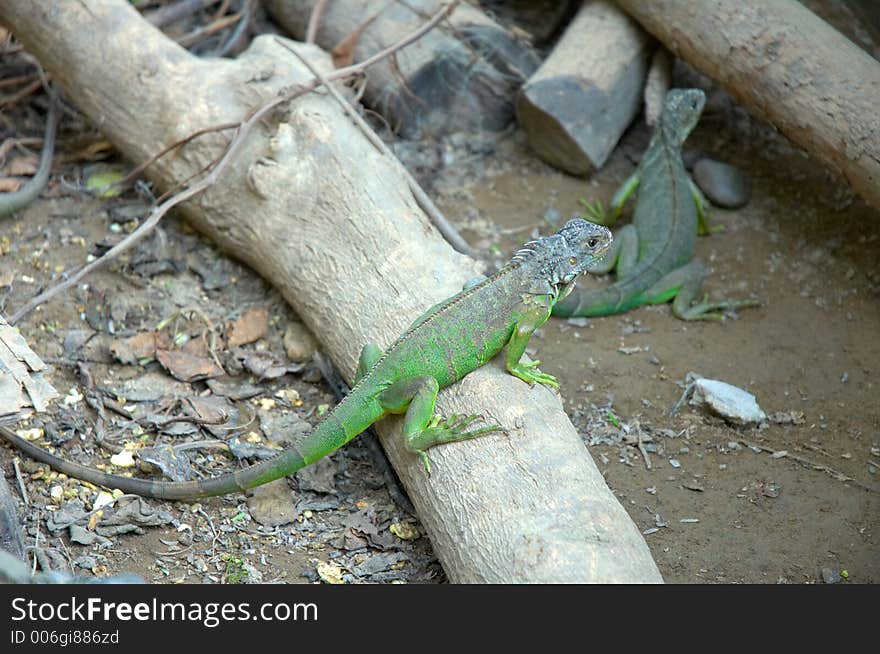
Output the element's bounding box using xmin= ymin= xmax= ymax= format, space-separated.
xmin=378 ymin=375 xmax=504 ymax=474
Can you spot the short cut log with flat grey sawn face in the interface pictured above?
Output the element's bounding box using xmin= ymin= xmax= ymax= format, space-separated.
xmin=516 ymin=0 xmax=655 ymax=175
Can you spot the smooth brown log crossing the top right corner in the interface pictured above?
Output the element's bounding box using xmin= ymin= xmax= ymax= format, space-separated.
xmin=618 ymin=0 xmax=880 ymax=208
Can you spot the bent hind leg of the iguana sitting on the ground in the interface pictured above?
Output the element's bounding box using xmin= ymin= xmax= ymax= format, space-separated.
xmin=645 ymin=261 xmax=760 ymax=320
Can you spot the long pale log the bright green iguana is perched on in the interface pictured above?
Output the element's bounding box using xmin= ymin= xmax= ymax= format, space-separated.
xmin=0 ymin=0 xmax=662 ymax=583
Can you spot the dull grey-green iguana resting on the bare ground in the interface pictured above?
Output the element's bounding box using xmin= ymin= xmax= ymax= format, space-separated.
xmin=553 ymin=89 xmax=758 ymax=320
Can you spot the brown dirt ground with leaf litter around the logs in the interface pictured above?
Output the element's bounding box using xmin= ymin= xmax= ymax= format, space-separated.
xmin=0 ymin=3 xmax=880 ymax=583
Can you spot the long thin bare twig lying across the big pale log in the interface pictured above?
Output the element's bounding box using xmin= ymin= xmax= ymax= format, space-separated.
xmin=9 ymin=0 xmax=458 ymax=325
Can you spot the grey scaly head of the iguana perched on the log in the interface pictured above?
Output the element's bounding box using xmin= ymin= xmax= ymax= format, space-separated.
xmin=513 ymin=218 xmax=611 ymax=299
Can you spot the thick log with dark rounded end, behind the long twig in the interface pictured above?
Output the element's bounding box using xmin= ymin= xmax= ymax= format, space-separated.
xmin=263 ymin=0 xmax=540 ymax=138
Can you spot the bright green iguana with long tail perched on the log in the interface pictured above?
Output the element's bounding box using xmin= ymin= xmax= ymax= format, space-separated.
xmin=0 ymin=218 xmax=612 ymax=500
